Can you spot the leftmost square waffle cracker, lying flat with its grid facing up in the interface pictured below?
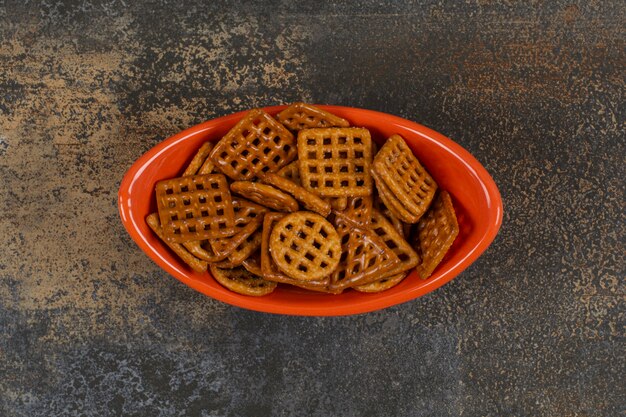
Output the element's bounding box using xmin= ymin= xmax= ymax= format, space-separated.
xmin=156 ymin=174 xmax=235 ymax=243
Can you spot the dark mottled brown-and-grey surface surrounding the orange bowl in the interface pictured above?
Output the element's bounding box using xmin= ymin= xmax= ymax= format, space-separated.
xmin=0 ymin=0 xmax=626 ymax=417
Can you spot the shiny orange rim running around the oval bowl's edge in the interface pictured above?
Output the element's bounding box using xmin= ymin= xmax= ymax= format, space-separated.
xmin=118 ymin=104 xmax=503 ymax=316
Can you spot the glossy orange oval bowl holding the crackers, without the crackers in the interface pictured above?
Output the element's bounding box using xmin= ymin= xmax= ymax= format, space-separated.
xmin=118 ymin=106 xmax=502 ymax=316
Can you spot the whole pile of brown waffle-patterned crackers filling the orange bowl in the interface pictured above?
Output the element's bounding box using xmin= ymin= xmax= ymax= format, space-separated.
xmin=146 ymin=103 xmax=459 ymax=296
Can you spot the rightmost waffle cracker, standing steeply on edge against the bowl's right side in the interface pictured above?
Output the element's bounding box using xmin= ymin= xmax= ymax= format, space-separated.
xmin=415 ymin=191 xmax=459 ymax=279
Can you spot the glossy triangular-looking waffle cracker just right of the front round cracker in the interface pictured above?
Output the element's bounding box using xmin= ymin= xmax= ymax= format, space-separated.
xmin=330 ymin=213 xmax=400 ymax=291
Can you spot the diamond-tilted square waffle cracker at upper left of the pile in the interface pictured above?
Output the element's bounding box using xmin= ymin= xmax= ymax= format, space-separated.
xmin=210 ymin=109 xmax=297 ymax=181
